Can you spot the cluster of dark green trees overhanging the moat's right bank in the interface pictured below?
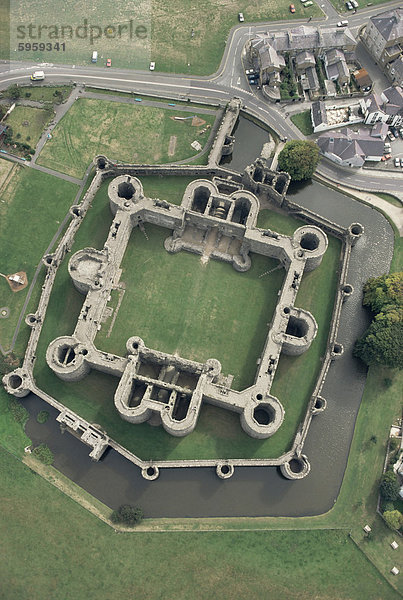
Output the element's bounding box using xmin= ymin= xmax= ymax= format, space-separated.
xmin=354 ymin=271 xmax=403 ymax=369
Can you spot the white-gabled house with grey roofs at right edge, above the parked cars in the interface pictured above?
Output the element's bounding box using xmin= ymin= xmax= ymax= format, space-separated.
xmin=360 ymin=86 xmax=403 ymax=126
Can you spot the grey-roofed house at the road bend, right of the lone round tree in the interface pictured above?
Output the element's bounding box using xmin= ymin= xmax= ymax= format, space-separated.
xmin=316 ymin=128 xmax=384 ymax=167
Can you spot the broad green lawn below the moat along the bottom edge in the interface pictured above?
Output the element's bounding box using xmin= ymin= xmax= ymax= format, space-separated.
xmin=0 ymin=442 xmax=399 ymax=600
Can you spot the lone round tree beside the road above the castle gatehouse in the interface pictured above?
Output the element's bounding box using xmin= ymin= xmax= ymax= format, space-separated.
xmin=278 ymin=140 xmax=319 ymax=181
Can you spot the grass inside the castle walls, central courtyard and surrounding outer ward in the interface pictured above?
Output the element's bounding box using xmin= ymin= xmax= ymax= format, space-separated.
xmin=35 ymin=177 xmax=340 ymax=459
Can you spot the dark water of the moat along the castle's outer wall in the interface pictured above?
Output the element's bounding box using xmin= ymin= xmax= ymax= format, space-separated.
xmin=23 ymin=119 xmax=394 ymax=517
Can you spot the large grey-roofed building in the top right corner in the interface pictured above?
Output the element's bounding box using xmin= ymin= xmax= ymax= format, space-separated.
xmin=362 ymin=7 xmax=403 ymax=73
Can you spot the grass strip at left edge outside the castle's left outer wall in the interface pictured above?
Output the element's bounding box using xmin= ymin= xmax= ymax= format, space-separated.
xmin=0 ymin=159 xmax=77 ymax=350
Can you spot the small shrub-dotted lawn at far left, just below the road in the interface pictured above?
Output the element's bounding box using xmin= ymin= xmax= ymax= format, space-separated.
xmin=6 ymin=106 xmax=53 ymax=151
